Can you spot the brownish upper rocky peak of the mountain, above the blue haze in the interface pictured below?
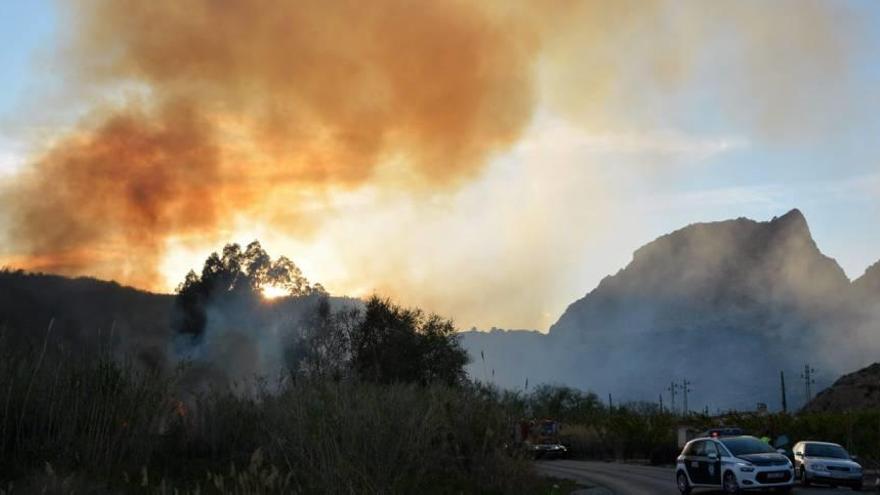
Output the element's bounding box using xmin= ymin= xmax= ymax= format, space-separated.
xmin=551 ymin=209 xmax=850 ymax=335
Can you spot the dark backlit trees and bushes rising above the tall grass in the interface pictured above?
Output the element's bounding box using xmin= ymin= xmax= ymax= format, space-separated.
xmin=174 ymin=241 xmax=468 ymax=385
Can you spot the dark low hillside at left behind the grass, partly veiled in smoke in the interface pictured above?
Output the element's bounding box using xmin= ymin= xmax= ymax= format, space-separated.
xmin=0 ymin=270 xmax=360 ymax=387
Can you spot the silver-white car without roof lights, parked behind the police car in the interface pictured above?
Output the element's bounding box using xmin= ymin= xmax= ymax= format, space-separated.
xmin=792 ymin=442 xmax=862 ymax=491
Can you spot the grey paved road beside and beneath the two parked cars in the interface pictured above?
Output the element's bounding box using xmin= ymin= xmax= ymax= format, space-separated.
xmin=536 ymin=460 xmax=873 ymax=495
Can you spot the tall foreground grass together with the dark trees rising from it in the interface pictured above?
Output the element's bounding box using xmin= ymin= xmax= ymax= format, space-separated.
xmin=0 ymin=244 xmax=546 ymax=494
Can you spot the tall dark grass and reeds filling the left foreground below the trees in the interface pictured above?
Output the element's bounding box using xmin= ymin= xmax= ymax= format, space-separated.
xmin=0 ymin=328 xmax=535 ymax=495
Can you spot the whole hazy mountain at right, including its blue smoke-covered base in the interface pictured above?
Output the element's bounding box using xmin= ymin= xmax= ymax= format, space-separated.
xmin=465 ymin=210 xmax=880 ymax=411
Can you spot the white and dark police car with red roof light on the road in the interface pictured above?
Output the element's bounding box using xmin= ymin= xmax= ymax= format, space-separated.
xmin=675 ymin=436 xmax=794 ymax=495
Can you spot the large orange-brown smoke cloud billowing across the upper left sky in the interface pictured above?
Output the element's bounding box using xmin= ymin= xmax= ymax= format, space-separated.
xmin=3 ymin=0 xmax=537 ymax=288
